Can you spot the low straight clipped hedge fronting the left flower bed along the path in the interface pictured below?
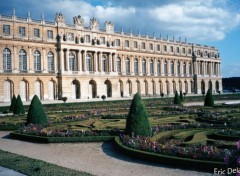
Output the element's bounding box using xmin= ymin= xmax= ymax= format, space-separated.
xmin=10 ymin=132 xmax=114 ymax=143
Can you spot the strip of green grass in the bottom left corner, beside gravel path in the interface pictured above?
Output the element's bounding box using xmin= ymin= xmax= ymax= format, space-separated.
xmin=0 ymin=150 xmax=94 ymax=176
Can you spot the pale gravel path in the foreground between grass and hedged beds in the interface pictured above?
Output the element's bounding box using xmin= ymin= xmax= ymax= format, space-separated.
xmin=0 ymin=132 xmax=212 ymax=176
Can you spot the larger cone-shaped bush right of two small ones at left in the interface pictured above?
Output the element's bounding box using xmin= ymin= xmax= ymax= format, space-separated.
xmin=26 ymin=95 xmax=48 ymax=125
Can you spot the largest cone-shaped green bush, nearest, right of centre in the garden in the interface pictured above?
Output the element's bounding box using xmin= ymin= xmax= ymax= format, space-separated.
xmin=125 ymin=93 xmax=151 ymax=137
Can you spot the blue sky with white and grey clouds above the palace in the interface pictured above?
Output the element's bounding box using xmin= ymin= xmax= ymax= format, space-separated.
xmin=0 ymin=0 xmax=240 ymax=77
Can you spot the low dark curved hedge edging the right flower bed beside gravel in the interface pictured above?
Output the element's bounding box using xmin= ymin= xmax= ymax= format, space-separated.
xmin=114 ymin=137 xmax=227 ymax=173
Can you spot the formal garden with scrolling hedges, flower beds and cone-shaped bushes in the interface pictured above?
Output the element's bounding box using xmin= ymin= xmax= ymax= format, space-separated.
xmin=0 ymin=91 xmax=240 ymax=172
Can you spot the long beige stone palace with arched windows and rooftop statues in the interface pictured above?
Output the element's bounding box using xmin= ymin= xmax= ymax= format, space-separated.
xmin=0 ymin=11 xmax=222 ymax=102
